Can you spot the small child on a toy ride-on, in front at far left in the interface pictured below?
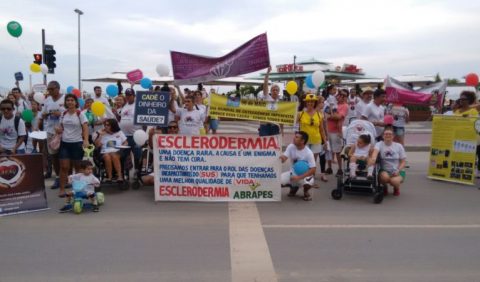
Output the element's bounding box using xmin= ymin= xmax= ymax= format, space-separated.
xmin=60 ymin=161 xmax=100 ymax=213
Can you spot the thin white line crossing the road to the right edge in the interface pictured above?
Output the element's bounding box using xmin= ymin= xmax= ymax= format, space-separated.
xmin=263 ymin=224 xmax=480 ymax=229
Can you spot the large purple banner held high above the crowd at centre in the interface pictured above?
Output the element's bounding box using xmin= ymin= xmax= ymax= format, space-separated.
xmin=170 ymin=33 xmax=270 ymax=84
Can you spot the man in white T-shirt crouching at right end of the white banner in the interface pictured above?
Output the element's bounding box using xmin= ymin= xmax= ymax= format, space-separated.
xmin=280 ymin=131 xmax=316 ymax=201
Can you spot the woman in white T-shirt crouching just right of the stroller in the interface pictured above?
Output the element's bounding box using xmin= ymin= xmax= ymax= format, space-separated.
xmin=372 ymin=127 xmax=407 ymax=196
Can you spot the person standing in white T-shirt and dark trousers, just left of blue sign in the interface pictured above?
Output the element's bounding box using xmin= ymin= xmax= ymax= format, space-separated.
xmin=118 ymin=88 xmax=142 ymax=174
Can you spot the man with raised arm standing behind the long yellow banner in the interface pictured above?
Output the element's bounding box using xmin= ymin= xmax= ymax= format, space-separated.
xmin=258 ymin=66 xmax=283 ymax=136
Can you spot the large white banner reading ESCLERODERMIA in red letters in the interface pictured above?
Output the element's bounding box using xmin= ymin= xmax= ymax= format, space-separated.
xmin=153 ymin=134 xmax=282 ymax=201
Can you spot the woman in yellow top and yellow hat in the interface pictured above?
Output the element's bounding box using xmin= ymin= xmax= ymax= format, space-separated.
xmin=297 ymin=94 xmax=328 ymax=182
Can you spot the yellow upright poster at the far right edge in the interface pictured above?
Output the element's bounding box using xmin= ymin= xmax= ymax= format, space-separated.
xmin=428 ymin=115 xmax=480 ymax=185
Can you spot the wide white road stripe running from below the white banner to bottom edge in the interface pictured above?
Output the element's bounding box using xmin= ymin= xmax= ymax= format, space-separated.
xmin=228 ymin=202 xmax=277 ymax=282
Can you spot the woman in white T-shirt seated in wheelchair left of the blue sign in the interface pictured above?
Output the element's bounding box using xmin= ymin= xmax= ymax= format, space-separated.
xmin=95 ymin=118 xmax=127 ymax=184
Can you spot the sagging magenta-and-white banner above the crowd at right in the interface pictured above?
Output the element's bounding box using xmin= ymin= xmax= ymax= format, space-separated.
xmin=385 ymin=77 xmax=447 ymax=108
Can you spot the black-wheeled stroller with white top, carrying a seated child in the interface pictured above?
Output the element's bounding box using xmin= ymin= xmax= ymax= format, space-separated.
xmin=331 ymin=120 xmax=383 ymax=204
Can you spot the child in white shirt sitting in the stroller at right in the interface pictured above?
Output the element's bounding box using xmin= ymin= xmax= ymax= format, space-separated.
xmin=348 ymin=134 xmax=374 ymax=179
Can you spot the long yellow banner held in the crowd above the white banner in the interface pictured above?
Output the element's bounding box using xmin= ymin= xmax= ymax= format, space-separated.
xmin=209 ymin=94 xmax=297 ymax=125
